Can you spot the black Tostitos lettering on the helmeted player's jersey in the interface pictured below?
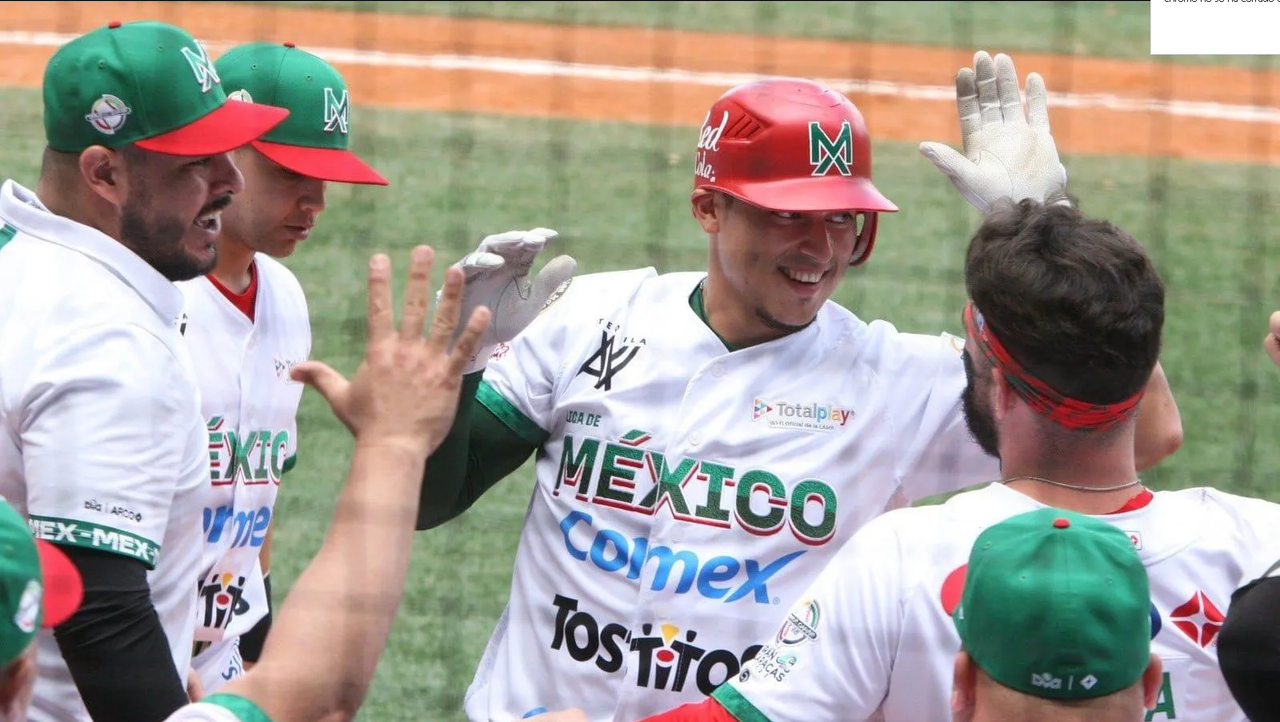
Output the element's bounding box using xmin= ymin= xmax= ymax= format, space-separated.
xmin=552 ymin=594 xmax=760 ymax=696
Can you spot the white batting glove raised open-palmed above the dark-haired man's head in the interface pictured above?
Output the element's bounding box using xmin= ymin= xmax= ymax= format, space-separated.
xmin=920 ymin=51 xmax=1066 ymax=214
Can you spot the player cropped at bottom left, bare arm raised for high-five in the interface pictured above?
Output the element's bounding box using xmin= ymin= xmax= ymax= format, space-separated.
xmin=0 ymin=246 xmax=489 ymax=722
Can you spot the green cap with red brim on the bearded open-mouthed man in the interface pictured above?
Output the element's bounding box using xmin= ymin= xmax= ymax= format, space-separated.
xmin=44 ymin=20 xmax=288 ymax=156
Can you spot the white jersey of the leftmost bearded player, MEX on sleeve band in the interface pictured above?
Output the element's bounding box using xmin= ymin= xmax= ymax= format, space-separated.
xmin=0 ymin=181 xmax=209 ymax=722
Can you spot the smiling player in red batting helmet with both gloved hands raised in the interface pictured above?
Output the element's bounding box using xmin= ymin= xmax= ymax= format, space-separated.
xmin=396 ymin=54 xmax=1178 ymax=721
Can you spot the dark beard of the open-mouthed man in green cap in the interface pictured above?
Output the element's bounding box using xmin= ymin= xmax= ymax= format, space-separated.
xmin=120 ymin=183 xmax=230 ymax=282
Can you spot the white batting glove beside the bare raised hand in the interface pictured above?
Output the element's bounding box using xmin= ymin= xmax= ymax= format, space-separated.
xmin=454 ymin=228 xmax=577 ymax=374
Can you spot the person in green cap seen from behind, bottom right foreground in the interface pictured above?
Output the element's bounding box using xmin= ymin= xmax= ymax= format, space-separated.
xmin=951 ymin=508 xmax=1164 ymax=722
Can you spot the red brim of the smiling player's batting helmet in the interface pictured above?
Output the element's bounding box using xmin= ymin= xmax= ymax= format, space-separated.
xmin=708 ymin=177 xmax=897 ymax=213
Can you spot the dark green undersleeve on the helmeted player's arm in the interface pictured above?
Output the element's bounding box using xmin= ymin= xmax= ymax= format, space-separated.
xmin=417 ymin=371 xmax=547 ymax=530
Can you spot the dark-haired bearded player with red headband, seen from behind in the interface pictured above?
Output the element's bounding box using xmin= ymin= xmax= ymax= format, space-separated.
xmin=654 ymin=200 xmax=1280 ymax=722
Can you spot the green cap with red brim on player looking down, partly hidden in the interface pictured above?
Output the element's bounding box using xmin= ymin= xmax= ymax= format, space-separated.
xmin=218 ymin=42 xmax=389 ymax=186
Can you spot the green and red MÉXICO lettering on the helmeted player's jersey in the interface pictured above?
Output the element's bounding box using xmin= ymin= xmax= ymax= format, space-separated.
xmin=552 ymin=430 xmax=838 ymax=547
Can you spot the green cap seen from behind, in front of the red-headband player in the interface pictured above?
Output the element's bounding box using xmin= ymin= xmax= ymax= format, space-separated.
xmin=952 ymin=508 xmax=1151 ymax=699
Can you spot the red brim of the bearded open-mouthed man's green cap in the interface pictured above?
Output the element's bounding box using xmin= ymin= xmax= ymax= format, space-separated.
xmin=133 ymin=99 xmax=289 ymax=156
